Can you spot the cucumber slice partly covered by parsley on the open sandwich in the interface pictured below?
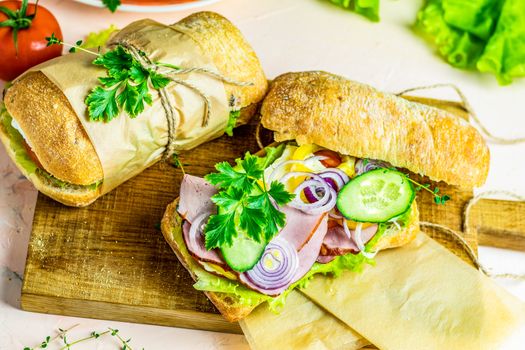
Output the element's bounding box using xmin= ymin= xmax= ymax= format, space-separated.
xmin=221 ymin=232 xmax=267 ymax=272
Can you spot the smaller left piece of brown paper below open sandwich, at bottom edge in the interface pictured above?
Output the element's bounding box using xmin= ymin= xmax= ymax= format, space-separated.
xmin=239 ymin=291 xmax=370 ymax=350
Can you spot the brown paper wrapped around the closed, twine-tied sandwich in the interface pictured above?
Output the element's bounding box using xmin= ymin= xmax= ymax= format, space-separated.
xmin=29 ymin=20 xmax=229 ymax=194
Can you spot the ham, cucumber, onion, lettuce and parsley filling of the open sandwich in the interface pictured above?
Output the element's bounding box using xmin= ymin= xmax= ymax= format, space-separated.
xmin=177 ymin=144 xmax=417 ymax=309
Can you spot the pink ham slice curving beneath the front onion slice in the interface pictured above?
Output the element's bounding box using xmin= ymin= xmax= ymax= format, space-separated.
xmin=239 ymin=215 xmax=328 ymax=296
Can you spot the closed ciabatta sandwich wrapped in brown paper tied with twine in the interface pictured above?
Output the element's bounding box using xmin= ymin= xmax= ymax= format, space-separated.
xmin=0 ymin=12 xmax=268 ymax=206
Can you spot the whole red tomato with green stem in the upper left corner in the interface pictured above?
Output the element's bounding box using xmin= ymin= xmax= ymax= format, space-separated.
xmin=0 ymin=0 xmax=63 ymax=80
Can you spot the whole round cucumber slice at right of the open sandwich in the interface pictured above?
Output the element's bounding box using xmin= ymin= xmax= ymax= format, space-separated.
xmin=337 ymin=169 xmax=416 ymax=222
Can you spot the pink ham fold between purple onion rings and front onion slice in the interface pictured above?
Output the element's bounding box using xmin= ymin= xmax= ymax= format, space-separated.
xmin=279 ymin=206 xmax=325 ymax=251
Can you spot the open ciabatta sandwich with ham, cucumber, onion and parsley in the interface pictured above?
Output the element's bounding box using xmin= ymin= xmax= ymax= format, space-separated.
xmin=162 ymin=72 xmax=489 ymax=321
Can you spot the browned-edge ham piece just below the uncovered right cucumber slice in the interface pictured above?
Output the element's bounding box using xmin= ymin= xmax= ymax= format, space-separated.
xmin=321 ymin=225 xmax=377 ymax=255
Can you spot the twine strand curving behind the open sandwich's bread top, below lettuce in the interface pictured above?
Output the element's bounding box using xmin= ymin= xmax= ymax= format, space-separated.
xmin=396 ymin=83 xmax=525 ymax=145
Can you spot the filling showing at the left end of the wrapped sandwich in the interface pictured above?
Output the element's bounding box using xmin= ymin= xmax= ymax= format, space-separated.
xmin=0 ymin=104 xmax=102 ymax=191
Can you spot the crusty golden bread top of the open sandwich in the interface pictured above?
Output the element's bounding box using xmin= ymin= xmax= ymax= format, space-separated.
xmin=261 ymin=72 xmax=490 ymax=188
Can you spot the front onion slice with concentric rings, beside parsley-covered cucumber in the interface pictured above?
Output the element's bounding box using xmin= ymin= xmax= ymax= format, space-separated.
xmin=244 ymin=236 xmax=299 ymax=290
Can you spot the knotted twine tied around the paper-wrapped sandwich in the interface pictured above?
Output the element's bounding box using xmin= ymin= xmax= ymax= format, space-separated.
xmin=123 ymin=42 xmax=253 ymax=159
